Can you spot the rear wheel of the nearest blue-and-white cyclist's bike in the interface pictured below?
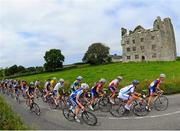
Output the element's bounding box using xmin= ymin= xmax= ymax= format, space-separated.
xmin=62 ymin=107 xmax=75 ymax=121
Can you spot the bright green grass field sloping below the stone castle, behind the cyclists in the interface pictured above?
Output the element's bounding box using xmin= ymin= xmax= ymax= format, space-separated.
xmin=15 ymin=61 xmax=180 ymax=94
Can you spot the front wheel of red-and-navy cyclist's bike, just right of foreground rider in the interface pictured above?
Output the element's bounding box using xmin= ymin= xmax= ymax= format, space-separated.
xmin=98 ymin=97 xmax=112 ymax=112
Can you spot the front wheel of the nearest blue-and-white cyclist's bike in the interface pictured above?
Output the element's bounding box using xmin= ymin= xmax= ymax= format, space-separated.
xmin=81 ymin=111 xmax=97 ymax=126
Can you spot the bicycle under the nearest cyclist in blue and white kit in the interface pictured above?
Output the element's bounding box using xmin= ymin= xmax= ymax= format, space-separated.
xmin=63 ymin=107 xmax=97 ymax=126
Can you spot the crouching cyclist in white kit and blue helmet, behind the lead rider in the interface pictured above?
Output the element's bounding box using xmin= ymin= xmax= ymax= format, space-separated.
xmin=118 ymin=80 xmax=141 ymax=110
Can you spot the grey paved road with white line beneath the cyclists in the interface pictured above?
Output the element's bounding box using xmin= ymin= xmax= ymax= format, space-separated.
xmin=0 ymin=94 xmax=180 ymax=130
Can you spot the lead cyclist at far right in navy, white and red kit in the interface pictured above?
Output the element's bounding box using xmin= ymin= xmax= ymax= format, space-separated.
xmin=147 ymin=74 xmax=166 ymax=111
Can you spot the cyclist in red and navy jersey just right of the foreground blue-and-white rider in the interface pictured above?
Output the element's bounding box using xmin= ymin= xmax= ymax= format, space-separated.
xmin=89 ymin=78 xmax=106 ymax=110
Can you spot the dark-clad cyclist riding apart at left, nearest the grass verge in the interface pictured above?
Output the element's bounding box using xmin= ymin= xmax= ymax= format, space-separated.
xmin=26 ymin=82 xmax=35 ymax=106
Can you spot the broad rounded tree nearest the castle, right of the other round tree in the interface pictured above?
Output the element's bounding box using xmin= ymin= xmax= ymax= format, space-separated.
xmin=82 ymin=43 xmax=111 ymax=65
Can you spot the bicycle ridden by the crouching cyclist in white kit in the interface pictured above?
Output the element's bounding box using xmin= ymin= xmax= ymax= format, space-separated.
xmin=110 ymin=96 xmax=148 ymax=117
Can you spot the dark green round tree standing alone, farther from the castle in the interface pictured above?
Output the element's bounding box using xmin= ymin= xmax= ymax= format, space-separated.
xmin=44 ymin=49 xmax=64 ymax=71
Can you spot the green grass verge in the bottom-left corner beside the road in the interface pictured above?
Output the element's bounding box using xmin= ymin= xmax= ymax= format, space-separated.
xmin=0 ymin=96 xmax=30 ymax=130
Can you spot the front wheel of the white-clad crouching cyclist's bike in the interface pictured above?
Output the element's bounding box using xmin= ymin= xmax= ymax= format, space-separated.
xmin=133 ymin=101 xmax=148 ymax=116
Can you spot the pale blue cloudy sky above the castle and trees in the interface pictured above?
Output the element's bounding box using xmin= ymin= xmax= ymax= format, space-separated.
xmin=0 ymin=0 xmax=180 ymax=68
